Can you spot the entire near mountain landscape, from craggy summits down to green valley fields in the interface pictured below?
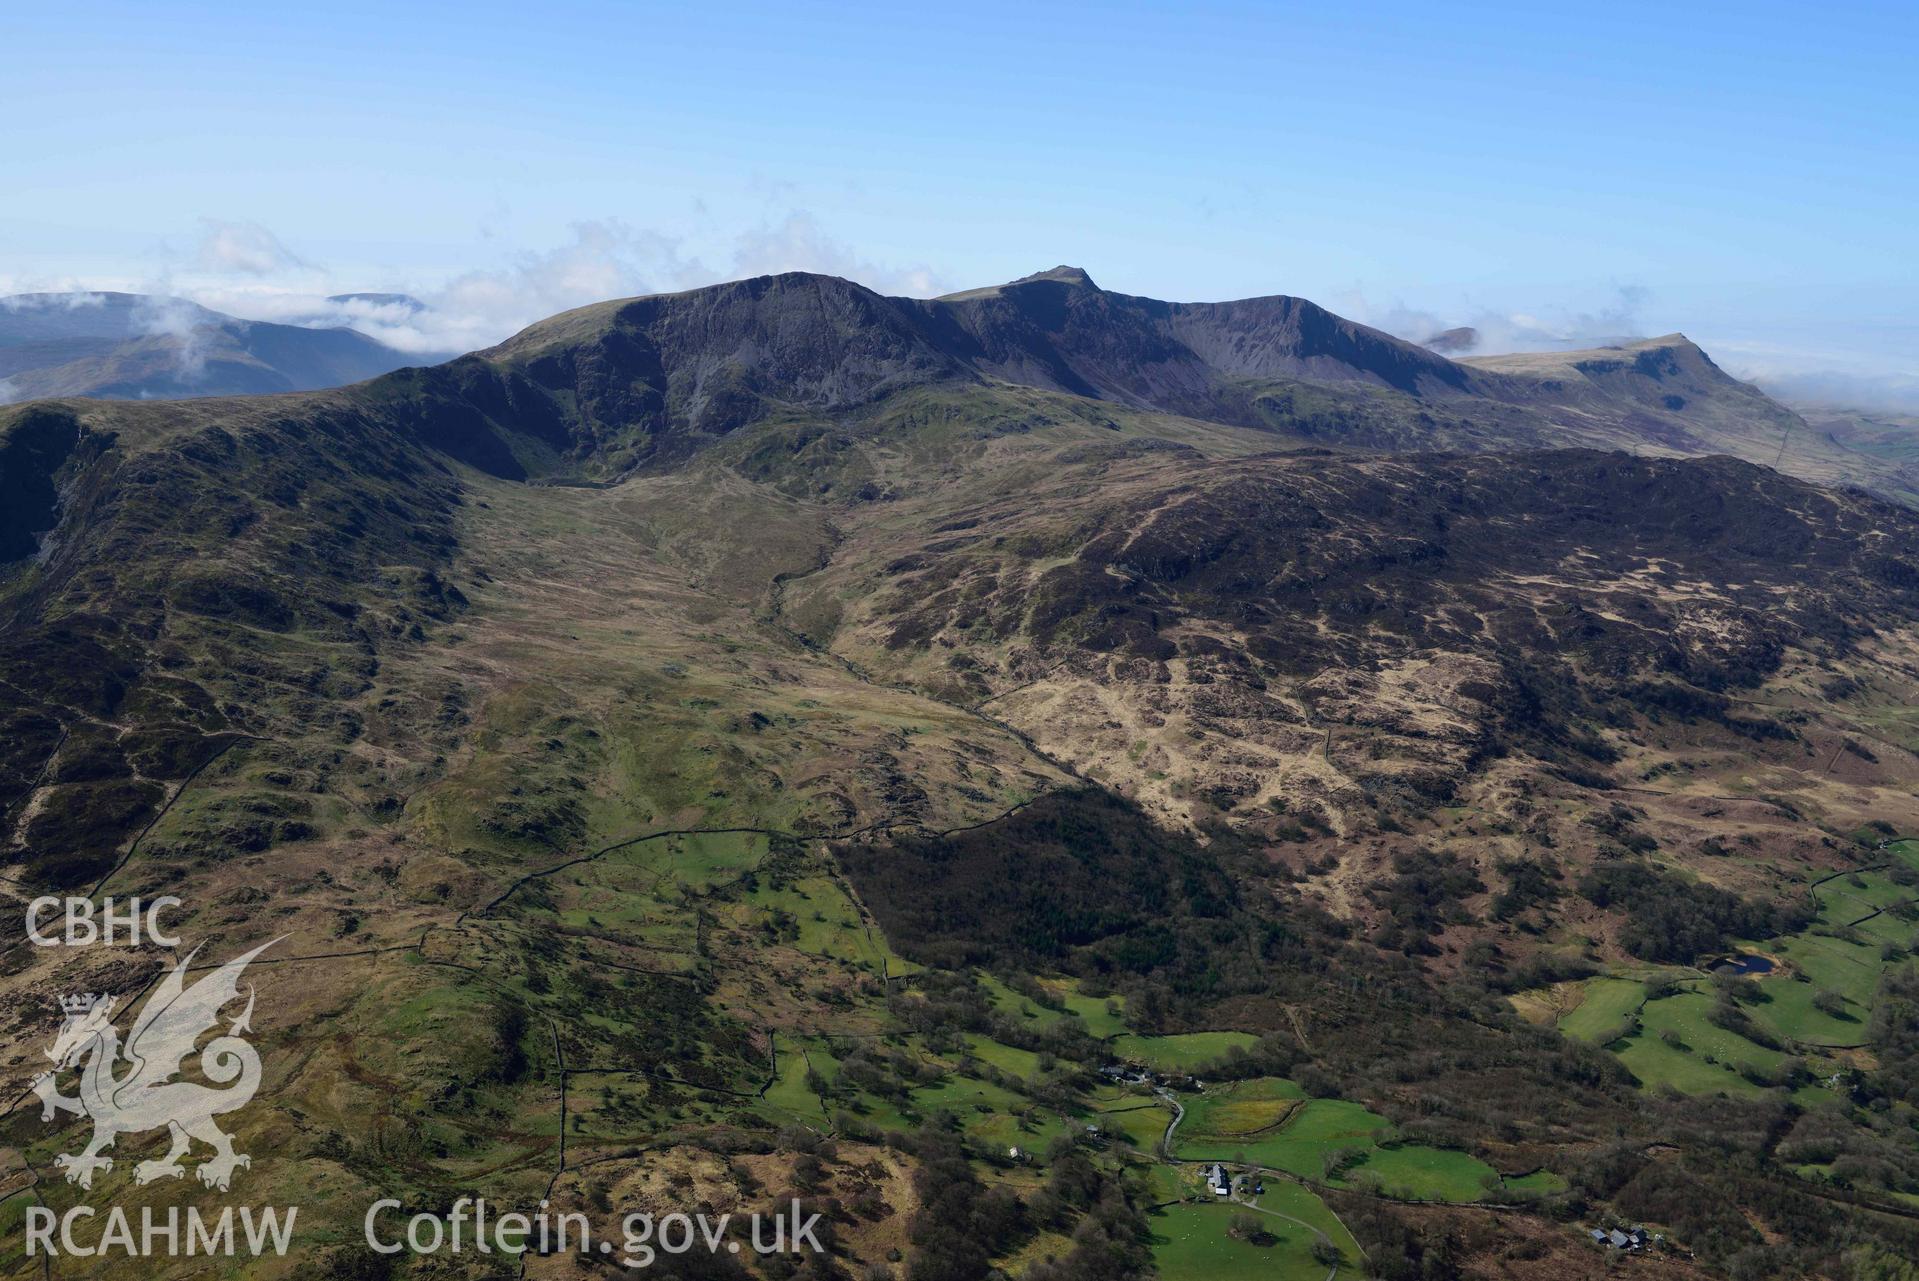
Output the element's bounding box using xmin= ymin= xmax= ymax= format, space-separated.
xmin=0 ymin=267 xmax=1919 ymax=1281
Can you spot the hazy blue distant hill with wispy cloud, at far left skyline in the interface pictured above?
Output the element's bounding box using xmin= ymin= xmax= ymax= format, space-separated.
xmin=0 ymin=293 xmax=431 ymax=401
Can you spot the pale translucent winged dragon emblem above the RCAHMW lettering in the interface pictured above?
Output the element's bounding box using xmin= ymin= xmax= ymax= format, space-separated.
xmin=33 ymin=940 xmax=280 ymax=1191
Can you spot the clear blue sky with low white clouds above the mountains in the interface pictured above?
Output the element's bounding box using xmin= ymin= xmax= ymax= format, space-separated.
xmin=11 ymin=0 xmax=1919 ymax=400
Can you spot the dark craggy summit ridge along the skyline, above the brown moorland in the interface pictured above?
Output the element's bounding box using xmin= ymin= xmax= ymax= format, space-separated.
xmin=381 ymin=267 xmax=1880 ymax=495
